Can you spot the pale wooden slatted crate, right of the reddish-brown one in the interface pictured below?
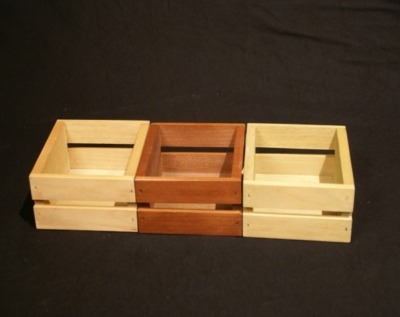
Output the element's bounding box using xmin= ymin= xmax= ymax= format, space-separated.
xmin=243 ymin=124 xmax=355 ymax=242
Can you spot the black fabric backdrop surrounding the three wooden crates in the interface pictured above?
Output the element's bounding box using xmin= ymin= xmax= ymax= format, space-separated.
xmin=0 ymin=0 xmax=400 ymax=316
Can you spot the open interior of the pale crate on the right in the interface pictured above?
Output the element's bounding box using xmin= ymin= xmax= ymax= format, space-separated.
xmin=254 ymin=126 xmax=341 ymax=183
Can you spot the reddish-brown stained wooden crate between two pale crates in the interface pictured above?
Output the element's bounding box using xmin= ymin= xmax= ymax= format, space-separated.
xmin=135 ymin=123 xmax=245 ymax=236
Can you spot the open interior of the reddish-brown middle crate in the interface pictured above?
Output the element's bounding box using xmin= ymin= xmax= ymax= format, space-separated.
xmin=145 ymin=125 xmax=243 ymax=178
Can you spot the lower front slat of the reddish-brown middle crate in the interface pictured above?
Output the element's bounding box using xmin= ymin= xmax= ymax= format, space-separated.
xmin=138 ymin=207 xmax=243 ymax=236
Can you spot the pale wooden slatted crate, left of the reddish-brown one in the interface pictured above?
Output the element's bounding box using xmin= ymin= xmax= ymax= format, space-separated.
xmin=29 ymin=120 xmax=149 ymax=232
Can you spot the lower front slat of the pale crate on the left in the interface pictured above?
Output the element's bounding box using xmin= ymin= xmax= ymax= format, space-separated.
xmin=34 ymin=202 xmax=138 ymax=232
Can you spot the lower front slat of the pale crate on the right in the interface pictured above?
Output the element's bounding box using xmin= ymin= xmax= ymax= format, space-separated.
xmin=243 ymin=211 xmax=352 ymax=242
